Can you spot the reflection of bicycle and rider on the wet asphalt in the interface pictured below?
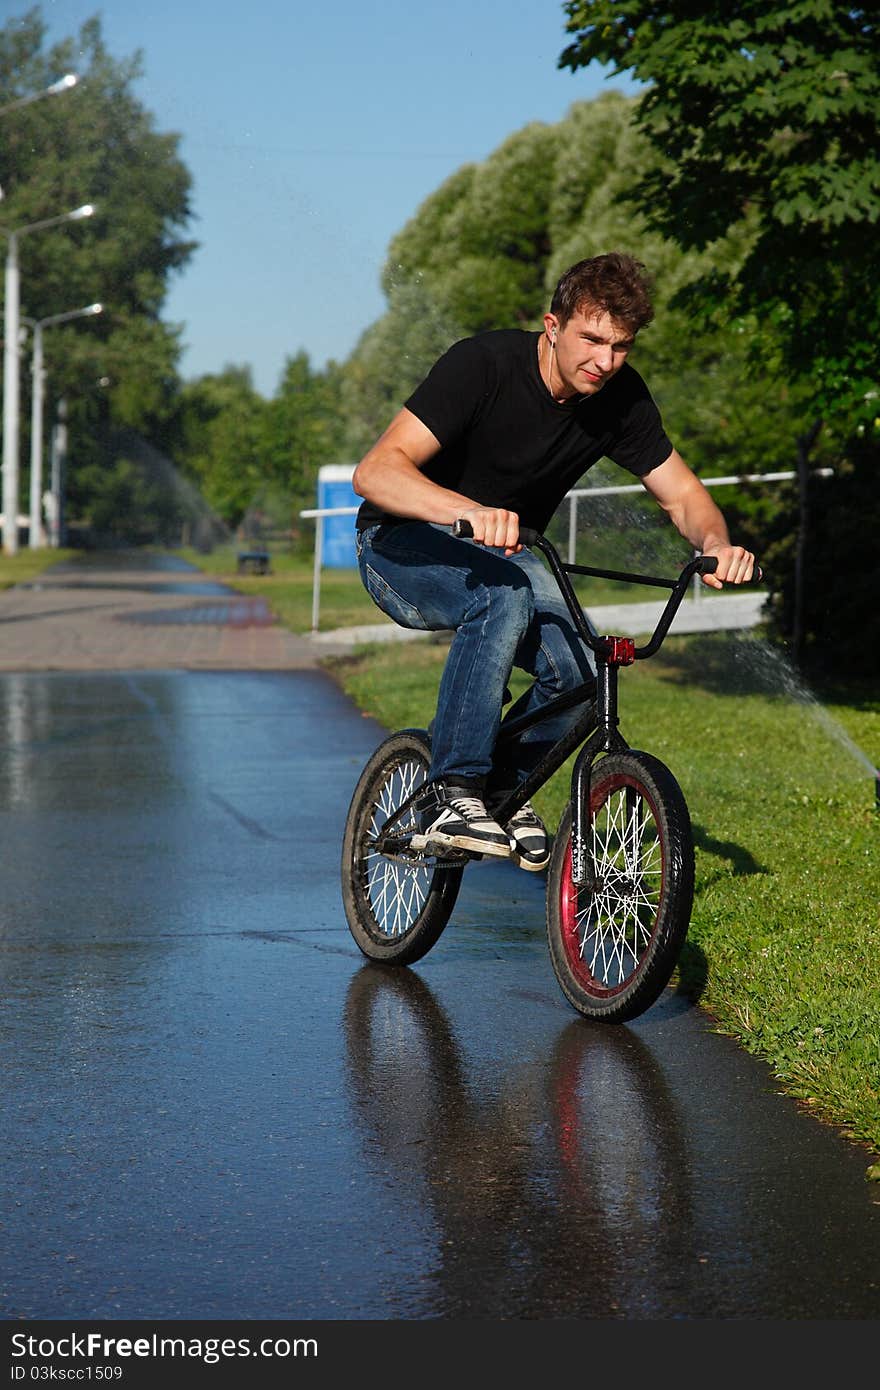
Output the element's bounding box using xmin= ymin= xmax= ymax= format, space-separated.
xmin=345 ymin=966 xmax=694 ymax=1318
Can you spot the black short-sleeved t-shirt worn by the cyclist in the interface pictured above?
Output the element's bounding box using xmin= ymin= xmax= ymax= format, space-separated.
xmin=357 ymin=328 xmax=673 ymax=531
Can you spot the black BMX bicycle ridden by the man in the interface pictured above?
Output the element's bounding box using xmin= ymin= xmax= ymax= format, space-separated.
xmin=342 ymin=521 xmax=760 ymax=1023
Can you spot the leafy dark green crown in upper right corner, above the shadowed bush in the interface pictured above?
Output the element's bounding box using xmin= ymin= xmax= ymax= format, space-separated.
xmin=559 ymin=0 xmax=880 ymax=432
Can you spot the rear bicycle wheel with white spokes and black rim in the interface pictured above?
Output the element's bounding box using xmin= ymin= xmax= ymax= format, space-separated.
xmin=342 ymin=728 xmax=466 ymax=965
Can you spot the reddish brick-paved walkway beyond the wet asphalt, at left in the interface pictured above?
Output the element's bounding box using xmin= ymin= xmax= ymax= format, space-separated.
xmin=0 ymin=552 xmax=343 ymax=671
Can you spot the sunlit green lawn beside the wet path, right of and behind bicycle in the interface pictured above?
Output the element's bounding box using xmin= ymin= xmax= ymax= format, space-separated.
xmin=322 ymin=634 xmax=880 ymax=1151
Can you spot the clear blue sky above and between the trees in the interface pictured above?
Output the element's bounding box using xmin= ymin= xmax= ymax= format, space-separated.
xmin=35 ymin=0 xmax=633 ymax=396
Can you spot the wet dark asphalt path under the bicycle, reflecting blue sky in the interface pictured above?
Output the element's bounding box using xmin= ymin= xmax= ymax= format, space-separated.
xmin=0 ymin=550 xmax=880 ymax=1321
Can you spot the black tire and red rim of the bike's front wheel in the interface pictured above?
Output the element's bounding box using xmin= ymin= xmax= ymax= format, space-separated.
xmin=546 ymin=749 xmax=694 ymax=1023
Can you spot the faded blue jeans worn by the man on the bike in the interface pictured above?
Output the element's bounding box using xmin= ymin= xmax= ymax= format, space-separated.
xmin=357 ymin=521 xmax=595 ymax=792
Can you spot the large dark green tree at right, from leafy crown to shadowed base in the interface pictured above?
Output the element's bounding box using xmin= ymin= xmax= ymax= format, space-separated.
xmin=559 ymin=0 xmax=880 ymax=663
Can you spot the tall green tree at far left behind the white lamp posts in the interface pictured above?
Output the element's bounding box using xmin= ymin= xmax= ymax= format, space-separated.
xmin=0 ymin=7 xmax=195 ymax=530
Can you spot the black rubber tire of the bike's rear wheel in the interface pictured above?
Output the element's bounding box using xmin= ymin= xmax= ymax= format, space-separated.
xmin=342 ymin=728 xmax=463 ymax=965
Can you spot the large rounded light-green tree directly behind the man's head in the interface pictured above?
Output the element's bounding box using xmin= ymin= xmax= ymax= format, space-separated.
xmin=343 ymin=92 xmax=817 ymax=505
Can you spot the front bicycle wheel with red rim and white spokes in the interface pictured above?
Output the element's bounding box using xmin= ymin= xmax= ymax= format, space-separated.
xmin=546 ymin=751 xmax=694 ymax=1023
